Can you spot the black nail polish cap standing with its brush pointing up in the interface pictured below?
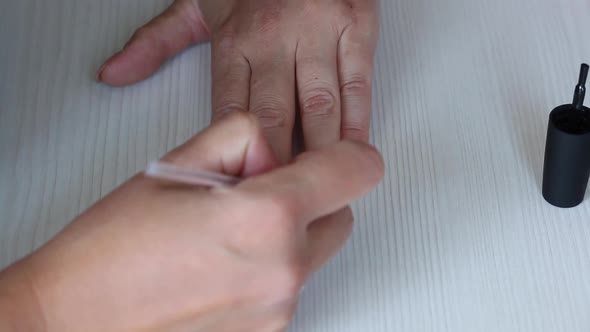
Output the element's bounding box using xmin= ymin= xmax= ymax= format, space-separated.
xmin=543 ymin=64 xmax=590 ymax=208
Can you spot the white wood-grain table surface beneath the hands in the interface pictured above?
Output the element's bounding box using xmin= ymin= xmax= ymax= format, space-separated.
xmin=0 ymin=0 xmax=590 ymax=332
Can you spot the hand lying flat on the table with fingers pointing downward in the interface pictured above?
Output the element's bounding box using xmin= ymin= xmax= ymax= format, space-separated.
xmin=98 ymin=0 xmax=378 ymax=162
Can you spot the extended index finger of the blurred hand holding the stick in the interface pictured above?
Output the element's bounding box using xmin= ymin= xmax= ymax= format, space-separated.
xmin=236 ymin=141 xmax=384 ymax=225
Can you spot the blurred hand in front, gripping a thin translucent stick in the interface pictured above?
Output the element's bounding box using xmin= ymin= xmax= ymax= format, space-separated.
xmin=0 ymin=113 xmax=383 ymax=332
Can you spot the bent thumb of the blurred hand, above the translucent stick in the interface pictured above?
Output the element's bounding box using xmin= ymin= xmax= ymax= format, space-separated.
xmin=162 ymin=112 xmax=278 ymax=177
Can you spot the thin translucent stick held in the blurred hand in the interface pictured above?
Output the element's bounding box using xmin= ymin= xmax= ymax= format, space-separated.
xmin=144 ymin=161 xmax=241 ymax=188
